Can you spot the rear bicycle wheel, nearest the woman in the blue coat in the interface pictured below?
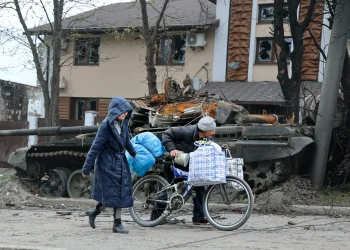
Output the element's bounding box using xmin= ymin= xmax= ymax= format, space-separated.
xmin=129 ymin=175 xmax=171 ymax=227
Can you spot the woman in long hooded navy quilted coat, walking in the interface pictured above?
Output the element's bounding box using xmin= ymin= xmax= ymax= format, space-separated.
xmin=82 ymin=97 xmax=136 ymax=233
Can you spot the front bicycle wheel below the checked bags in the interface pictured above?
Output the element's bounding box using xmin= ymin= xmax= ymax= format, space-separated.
xmin=204 ymin=176 xmax=254 ymax=231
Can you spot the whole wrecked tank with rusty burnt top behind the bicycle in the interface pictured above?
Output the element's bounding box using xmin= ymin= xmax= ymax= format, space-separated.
xmin=0 ymin=78 xmax=313 ymax=198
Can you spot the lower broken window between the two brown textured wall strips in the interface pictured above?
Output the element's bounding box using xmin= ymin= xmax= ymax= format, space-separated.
xmin=256 ymin=37 xmax=293 ymax=63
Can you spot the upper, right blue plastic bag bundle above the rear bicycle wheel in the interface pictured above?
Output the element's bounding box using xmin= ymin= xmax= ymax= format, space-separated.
xmin=131 ymin=132 xmax=165 ymax=158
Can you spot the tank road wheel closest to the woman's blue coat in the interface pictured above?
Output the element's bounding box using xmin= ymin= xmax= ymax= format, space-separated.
xmin=67 ymin=170 xmax=94 ymax=198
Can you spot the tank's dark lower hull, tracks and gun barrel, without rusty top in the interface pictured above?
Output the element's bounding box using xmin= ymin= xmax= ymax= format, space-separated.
xmin=0 ymin=122 xmax=313 ymax=198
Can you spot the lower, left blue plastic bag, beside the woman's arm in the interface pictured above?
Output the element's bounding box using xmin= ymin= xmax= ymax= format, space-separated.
xmin=125 ymin=144 xmax=156 ymax=177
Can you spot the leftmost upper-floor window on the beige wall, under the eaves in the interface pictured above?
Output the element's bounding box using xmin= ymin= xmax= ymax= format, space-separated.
xmin=75 ymin=37 xmax=100 ymax=65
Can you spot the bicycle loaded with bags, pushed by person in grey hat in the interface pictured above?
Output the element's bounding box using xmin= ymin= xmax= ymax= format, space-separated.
xmin=129 ymin=158 xmax=254 ymax=231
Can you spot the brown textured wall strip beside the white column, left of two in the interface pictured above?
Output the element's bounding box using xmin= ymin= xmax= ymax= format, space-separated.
xmin=227 ymin=0 xmax=252 ymax=81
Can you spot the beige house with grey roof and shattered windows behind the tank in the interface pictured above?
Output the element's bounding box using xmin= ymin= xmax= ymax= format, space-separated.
xmin=36 ymin=0 xmax=340 ymax=120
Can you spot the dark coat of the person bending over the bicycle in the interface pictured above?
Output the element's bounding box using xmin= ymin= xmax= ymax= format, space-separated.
xmin=162 ymin=125 xmax=199 ymax=153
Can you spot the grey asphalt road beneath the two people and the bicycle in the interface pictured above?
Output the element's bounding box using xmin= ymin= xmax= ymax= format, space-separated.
xmin=0 ymin=209 xmax=350 ymax=250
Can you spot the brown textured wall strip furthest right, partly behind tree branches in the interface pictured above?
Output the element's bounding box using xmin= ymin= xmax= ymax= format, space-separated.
xmin=300 ymin=0 xmax=324 ymax=81
